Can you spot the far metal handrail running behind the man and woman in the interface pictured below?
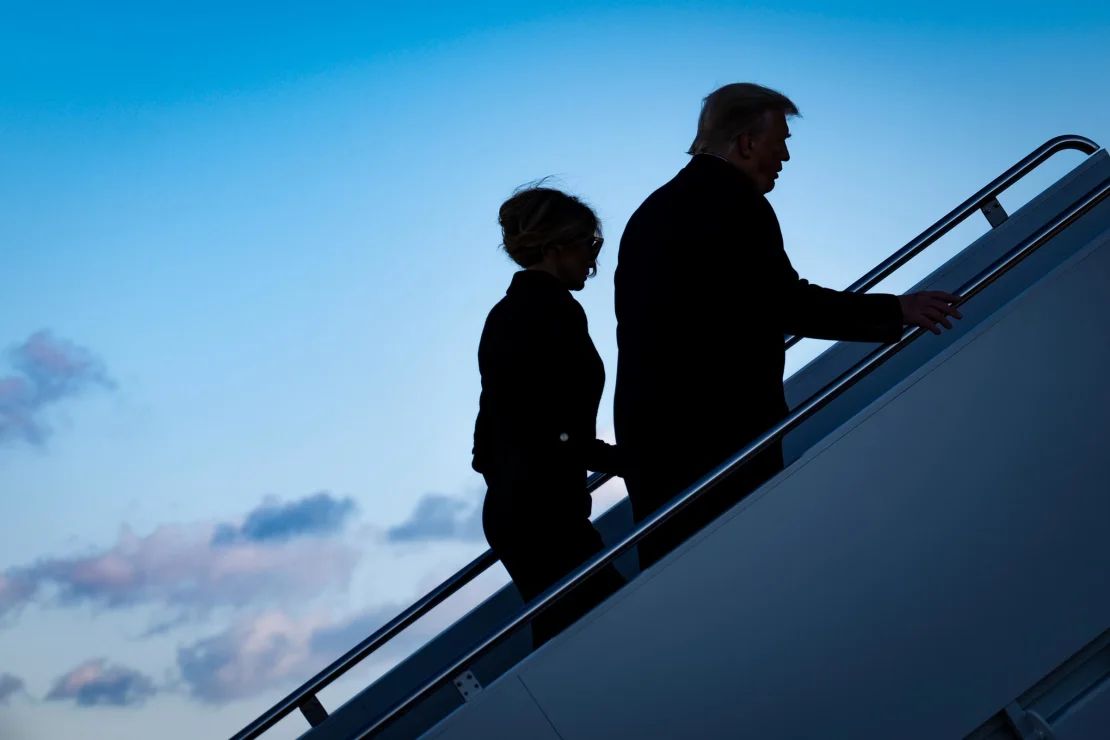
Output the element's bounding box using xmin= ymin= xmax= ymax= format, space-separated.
xmin=231 ymin=134 xmax=1099 ymax=740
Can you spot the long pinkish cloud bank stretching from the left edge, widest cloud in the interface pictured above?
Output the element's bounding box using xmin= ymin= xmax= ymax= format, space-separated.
xmin=0 ymin=494 xmax=359 ymax=621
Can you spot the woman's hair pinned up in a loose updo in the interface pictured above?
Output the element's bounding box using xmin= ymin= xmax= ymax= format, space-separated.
xmin=497 ymin=180 xmax=602 ymax=267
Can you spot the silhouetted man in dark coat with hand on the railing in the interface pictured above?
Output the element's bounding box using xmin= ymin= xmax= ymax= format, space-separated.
xmin=615 ymin=83 xmax=960 ymax=567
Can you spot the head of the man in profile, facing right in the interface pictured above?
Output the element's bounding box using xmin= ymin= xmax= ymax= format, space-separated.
xmin=689 ymin=82 xmax=799 ymax=193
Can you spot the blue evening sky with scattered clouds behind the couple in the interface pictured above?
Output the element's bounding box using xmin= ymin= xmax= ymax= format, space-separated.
xmin=0 ymin=1 xmax=1110 ymax=740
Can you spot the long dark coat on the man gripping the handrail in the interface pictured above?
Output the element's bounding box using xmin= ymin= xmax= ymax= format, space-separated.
xmin=615 ymin=154 xmax=902 ymax=505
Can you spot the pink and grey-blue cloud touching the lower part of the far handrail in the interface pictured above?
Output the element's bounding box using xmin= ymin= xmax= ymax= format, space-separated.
xmin=178 ymin=607 xmax=398 ymax=703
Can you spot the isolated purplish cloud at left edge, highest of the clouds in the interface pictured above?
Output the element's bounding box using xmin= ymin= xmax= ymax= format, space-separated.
xmin=0 ymin=331 xmax=114 ymax=447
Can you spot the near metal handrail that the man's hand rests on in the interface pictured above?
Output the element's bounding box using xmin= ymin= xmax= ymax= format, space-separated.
xmin=355 ymin=178 xmax=1110 ymax=740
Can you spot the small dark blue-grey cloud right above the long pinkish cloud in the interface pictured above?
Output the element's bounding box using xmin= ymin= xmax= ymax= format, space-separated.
xmin=212 ymin=491 xmax=355 ymax=545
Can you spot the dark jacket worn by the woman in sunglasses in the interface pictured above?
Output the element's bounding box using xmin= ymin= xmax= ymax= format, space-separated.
xmin=474 ymin=270 xmax=616 ymax=535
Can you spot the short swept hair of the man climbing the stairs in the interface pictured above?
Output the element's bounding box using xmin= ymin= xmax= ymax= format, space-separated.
xmin=687 ymin=82 xmax=800 ymax=154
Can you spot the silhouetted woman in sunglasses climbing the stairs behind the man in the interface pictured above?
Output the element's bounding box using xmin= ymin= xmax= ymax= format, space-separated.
xmin=474 ymin=186 xmax=624 ymax=647
